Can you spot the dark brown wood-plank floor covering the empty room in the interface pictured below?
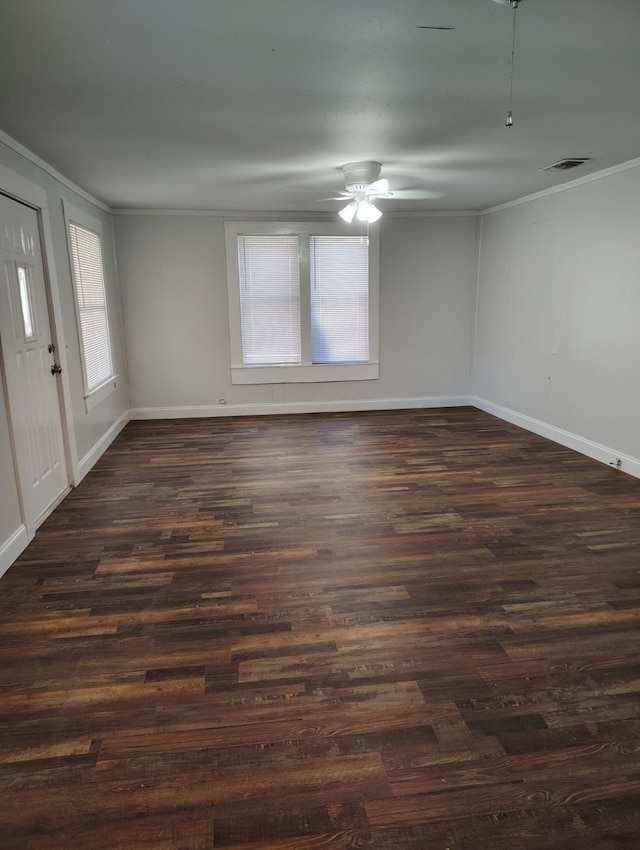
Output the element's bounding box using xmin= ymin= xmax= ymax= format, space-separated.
xmin=0 ymin=408 xmax=640 ymax=850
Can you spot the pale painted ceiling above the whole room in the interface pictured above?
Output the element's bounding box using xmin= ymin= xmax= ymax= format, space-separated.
xmin=0 ymin=0 xmax=640 ymax=211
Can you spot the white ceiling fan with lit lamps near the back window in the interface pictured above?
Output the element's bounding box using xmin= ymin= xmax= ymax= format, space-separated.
xmin=326 ymin=161 xmax=440 ymax=224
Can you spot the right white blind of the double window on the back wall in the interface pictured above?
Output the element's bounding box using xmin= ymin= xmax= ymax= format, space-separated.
xmin=309 ymin=236 xmax=369 ymax=363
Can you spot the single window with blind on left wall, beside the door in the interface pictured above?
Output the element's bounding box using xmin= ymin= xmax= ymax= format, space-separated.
xmin=65 ymin=204 xmax=117 ymax=410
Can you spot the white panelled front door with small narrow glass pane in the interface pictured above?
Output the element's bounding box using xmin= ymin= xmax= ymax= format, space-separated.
xmin=0 ymin=195 xmax=69 ymax=533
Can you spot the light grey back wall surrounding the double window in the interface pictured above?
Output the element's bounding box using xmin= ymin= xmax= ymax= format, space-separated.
xmin=115 ymin=209 xmax=477 ymax=417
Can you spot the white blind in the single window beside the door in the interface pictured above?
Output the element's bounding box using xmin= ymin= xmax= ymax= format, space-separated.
xmin=69 ymin=222 xmax=113 ymax=393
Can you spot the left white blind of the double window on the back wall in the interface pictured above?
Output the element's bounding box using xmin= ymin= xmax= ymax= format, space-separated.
xmin=238 ymin=235 xmax=301 ymax=365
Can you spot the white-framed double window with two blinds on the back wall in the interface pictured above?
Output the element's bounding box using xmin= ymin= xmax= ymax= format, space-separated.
xmin=225 ymin=222 xmax=378 ymax=384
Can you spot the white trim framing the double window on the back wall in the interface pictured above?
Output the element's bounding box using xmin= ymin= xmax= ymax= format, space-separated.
xmin=224 ymin=221 xmax=380 ymax=385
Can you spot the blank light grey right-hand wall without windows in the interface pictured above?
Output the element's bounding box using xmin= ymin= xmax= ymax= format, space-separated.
xmin=474 ymin=164 xmax=640 ymax=474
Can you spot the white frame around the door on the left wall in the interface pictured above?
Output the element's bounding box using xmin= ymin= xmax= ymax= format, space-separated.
xmin=0 ymin=165 xmax=81 ymax=541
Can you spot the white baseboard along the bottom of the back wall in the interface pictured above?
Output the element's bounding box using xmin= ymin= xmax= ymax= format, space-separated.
xmin=129 ymin=395 xmax=474 ymax=419
